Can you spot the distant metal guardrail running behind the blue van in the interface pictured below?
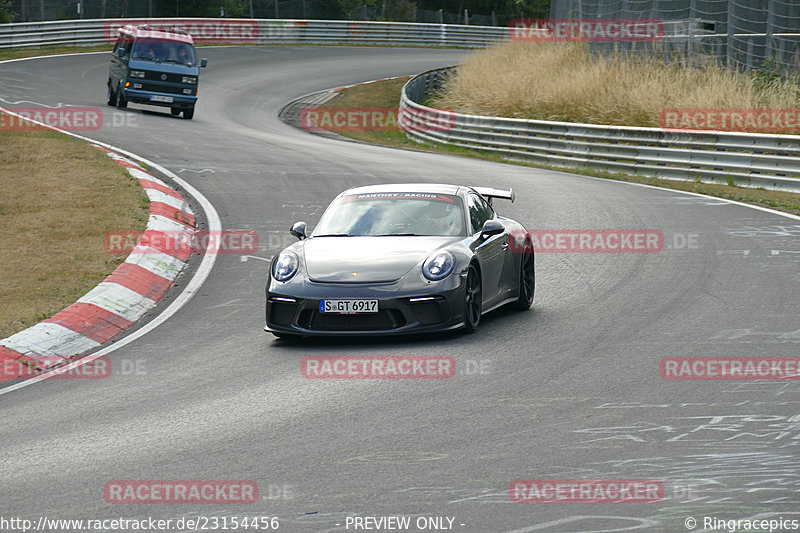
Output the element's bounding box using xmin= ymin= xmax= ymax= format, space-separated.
xmin=0 ymin=18 xmax=509 ymax=48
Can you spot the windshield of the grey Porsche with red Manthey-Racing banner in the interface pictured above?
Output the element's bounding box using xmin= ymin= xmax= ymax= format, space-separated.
xmin=313 ymin=193 xmax=464 ymax=237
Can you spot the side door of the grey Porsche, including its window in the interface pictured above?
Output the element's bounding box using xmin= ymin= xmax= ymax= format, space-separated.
xmin=467 ymin=192 xmax=508 ymax=308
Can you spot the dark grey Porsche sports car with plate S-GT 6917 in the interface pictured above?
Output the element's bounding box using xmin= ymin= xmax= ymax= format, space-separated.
xmin=264 ymin=183 xmax=535 ymax=337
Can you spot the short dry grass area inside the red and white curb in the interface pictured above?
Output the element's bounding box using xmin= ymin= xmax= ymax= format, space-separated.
xmin=0 ymin=117 xmax=149 ymax=338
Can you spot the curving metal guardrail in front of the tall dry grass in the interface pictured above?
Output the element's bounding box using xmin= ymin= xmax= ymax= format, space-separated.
xmin=398 ymin=67 xmax=800 ymax=192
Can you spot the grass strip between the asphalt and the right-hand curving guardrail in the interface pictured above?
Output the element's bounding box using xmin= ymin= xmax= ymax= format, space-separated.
xmin=304 ymin=78 xmax=800 ymax=215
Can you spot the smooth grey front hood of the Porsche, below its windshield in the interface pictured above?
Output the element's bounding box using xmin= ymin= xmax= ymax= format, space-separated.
xmin=302 ymin=236 xmax=463 ymax=283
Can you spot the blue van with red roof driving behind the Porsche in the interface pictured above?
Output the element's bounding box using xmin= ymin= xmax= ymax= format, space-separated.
xmin=107 ymin=25 xmax=208 ymax=119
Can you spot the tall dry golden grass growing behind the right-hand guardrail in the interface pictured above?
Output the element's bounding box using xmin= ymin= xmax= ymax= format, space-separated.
xmin=431 ymin=42 xmax=800 ymax=127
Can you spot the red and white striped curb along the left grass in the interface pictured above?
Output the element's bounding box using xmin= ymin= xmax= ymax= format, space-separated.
xmin=0 ymin=146 xmax=195 ymax=381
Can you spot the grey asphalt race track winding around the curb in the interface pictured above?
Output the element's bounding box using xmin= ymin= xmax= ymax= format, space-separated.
xmin=0 ymin=46 xmax=800 ymax=533
